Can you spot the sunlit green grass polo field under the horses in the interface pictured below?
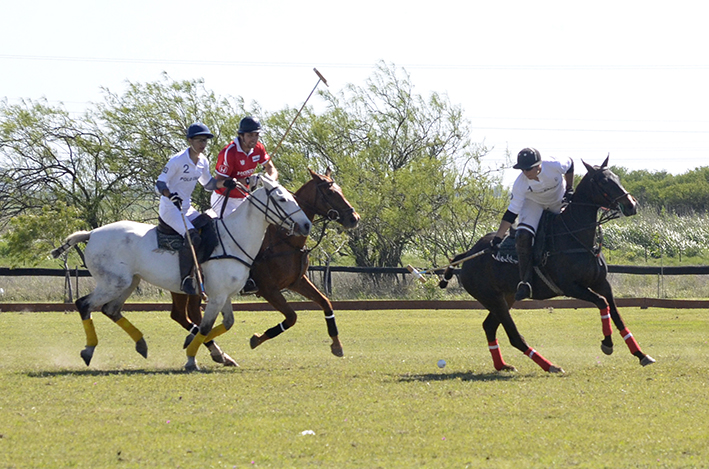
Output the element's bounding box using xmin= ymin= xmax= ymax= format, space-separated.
xmin=0 ymin=308 xmax=709 ymax=468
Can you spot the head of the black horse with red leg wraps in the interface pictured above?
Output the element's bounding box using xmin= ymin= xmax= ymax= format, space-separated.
xmin=574 ymin=157 xmax=638 ymax=217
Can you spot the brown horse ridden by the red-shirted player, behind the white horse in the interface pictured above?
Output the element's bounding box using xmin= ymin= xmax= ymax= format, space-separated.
xmin=170 ymin=167 xmax=360 ymax=358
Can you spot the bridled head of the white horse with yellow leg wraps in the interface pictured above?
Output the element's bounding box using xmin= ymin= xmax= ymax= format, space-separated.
xmin=250 ymin=175 xmax=312 ymax=236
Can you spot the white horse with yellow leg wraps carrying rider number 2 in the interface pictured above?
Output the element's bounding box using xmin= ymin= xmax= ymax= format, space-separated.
xmin=52 ymin=176 xmax=311 ymax=370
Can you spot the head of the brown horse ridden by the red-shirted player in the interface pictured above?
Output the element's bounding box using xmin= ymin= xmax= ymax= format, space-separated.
xmin=295 ymin=167 xmax=359 ymax=229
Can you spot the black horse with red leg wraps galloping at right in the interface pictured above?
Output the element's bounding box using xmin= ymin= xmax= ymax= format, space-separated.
xmin=439 ymin=158 xmax=655 ymax=373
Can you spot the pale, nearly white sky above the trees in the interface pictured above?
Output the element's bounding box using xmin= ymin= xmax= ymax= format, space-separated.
xmin=0 ymin=0 xmax=709 ymax=185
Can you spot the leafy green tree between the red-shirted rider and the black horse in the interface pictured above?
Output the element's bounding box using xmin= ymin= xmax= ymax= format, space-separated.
xmin=266 ymin=63 xmax=499 ymax=266
